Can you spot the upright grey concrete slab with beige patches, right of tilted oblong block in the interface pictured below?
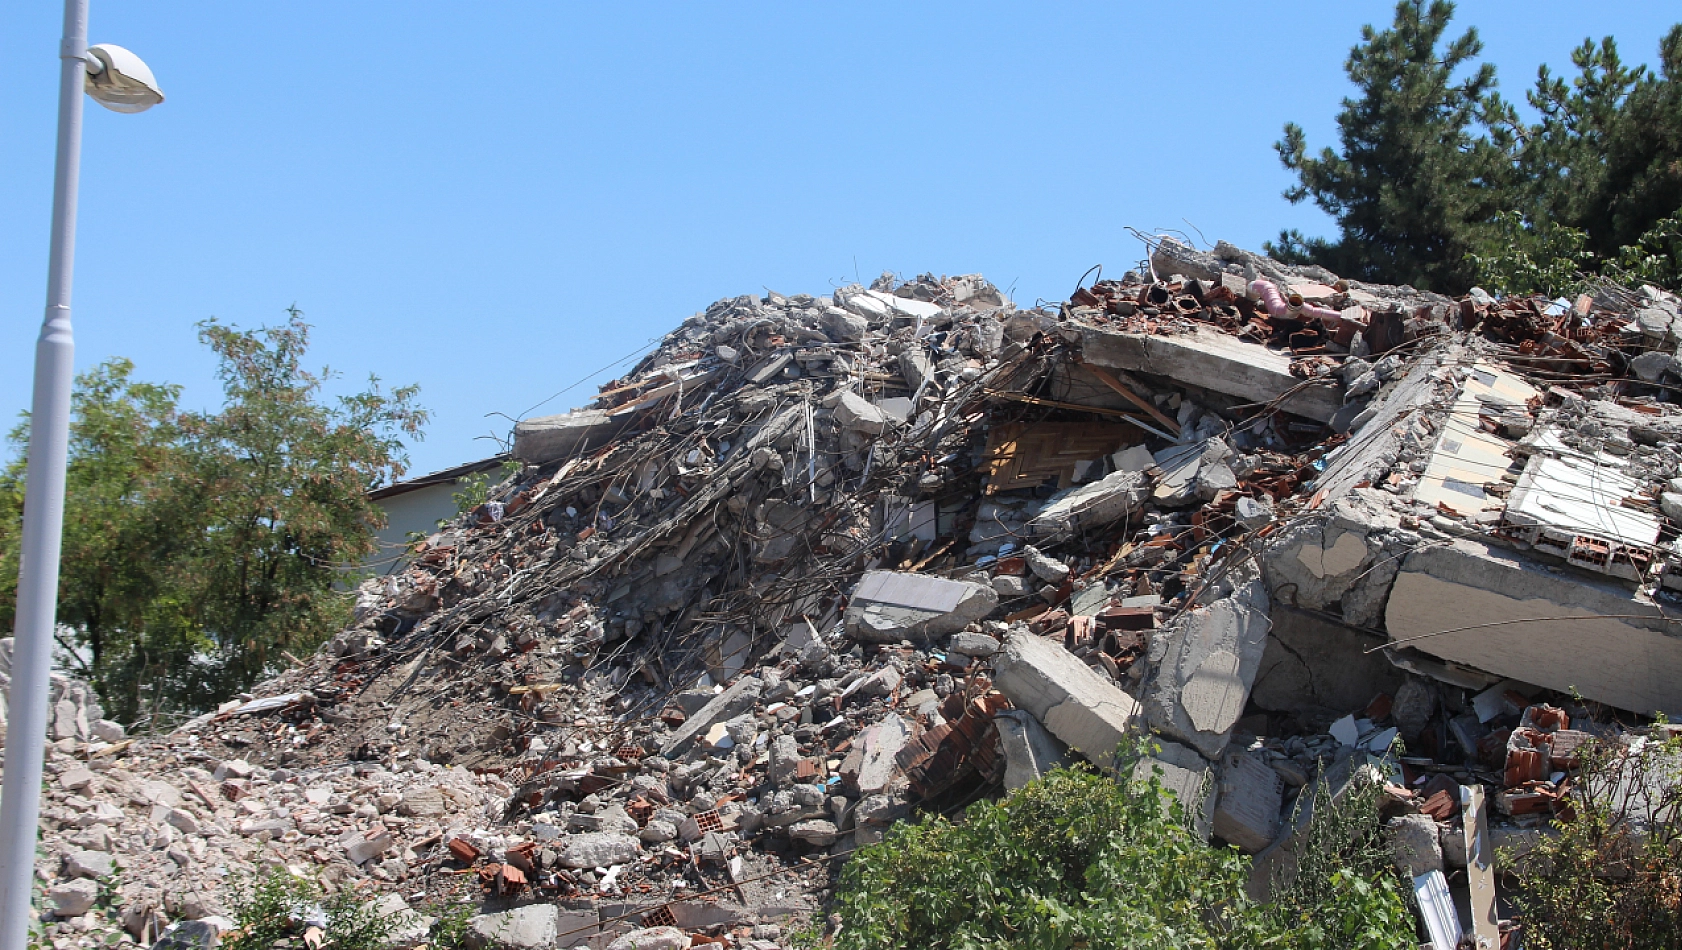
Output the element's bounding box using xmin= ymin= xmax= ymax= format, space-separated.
xmin=1144 ymin=568 xmax=1268 ymax=758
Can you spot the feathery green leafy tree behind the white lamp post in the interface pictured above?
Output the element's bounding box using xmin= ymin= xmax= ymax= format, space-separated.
xmin=0 ymin=311 xmax=426 ymax=721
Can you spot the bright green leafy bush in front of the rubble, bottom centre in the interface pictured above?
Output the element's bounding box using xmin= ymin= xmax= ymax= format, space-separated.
xmin=820 ymin=753 xmax=1416 ymax=950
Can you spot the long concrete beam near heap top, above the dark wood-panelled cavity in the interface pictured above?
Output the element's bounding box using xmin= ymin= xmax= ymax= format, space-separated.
xmin=1080 ymin=326 xmax=1344 ymax=422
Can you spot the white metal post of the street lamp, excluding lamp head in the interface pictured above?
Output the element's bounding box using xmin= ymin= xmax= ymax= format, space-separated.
xmin=0 ymin=0 xmax=87 ymax=950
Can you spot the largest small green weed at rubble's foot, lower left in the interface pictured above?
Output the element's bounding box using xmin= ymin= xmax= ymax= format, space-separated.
xmin=222 ymin=869 xmax=395 ymax=950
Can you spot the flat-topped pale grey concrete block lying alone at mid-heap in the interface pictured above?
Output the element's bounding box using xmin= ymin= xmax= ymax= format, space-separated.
xmin=843 ymin=570 xmax=999 ymax=642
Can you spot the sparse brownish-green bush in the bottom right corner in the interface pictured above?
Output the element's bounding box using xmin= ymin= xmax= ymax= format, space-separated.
xmin=1502 ymin=738 xmax=1682 ymax=950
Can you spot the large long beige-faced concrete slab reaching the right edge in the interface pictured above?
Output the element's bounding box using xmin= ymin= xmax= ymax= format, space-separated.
xmin=1384 ymin=538 xmax=1682 ymax=715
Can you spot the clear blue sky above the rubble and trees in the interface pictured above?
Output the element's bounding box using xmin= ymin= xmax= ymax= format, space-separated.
xmin=0 ymin=0 xmax=1682 ymax=472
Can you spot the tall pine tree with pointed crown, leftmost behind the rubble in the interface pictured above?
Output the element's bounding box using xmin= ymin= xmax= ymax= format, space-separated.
xmin=1268 ymin=0 xmax=1512 ymax=293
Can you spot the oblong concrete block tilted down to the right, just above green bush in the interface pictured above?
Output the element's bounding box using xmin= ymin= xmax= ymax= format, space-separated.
xmin=992 ymin=631 xmax=1139 ymax=767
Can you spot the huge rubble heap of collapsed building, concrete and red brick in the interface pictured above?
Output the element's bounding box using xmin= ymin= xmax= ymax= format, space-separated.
xmin=19 ymin=240 xmax=1682 ymax=947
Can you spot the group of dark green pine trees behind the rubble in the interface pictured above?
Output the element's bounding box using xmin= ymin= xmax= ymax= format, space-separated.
xmin=1268 ymin=0 xmax=1682 ymax=293
